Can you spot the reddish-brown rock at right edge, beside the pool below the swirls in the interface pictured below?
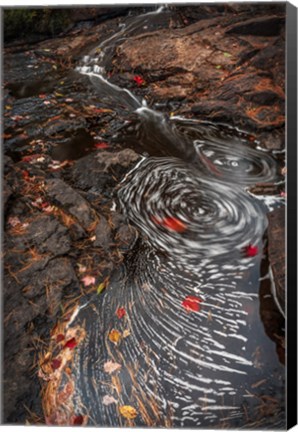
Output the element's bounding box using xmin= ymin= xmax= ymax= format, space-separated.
xmin=268 ymin=207 xmax=285 ymax=312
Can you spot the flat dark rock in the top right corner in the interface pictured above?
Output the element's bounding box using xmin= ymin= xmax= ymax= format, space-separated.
xmin=226 ymin=16 xmax=285 ymax=36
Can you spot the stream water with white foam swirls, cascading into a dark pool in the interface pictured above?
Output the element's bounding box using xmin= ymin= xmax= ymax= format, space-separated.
xmin=57 ymin=8 xmax=285 ymax=429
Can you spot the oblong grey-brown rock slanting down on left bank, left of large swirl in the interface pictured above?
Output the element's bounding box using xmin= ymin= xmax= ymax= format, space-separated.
xmin=46 ymin=174 xmax=94 ymax=230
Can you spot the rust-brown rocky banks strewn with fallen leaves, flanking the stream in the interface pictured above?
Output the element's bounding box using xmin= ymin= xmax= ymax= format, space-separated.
xmin=2 ymin=3 xmax=285 ymax=424
